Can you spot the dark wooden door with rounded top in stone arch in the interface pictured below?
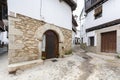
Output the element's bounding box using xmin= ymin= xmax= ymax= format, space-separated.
xmin=45 ymin=30 xmax=58 ymax=59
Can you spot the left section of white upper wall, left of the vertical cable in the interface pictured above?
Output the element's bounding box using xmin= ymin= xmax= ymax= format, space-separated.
xmin=8 ymin=0 xmax=40 ymax=19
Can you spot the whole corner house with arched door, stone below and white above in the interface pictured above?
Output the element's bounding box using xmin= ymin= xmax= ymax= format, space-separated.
xmin=8 ymin=0 xmax=77 ymax=71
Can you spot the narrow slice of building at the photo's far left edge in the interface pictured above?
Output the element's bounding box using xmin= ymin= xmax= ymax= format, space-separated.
xmin=0 ymin=0 xmax=8 ymax=46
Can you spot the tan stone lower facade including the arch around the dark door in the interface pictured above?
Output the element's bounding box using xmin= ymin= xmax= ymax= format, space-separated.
xmin=8 ymin=14 xmax=72 ymax=64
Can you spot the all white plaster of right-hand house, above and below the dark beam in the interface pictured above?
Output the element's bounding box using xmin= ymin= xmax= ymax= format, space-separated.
xmin=81 ymin=0 xmax=120 ymax=46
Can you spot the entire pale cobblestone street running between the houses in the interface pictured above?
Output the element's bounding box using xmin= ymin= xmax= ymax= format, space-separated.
xmin=0 ymin=46 xmax=120 ymax=80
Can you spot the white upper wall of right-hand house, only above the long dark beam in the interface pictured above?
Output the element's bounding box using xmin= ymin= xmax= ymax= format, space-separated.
xmin=85 ymin=0 xmax=120 ymax=28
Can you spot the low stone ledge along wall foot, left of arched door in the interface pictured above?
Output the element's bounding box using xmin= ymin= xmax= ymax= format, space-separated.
xmin=8 ymin=59 xmax=43 ymax=73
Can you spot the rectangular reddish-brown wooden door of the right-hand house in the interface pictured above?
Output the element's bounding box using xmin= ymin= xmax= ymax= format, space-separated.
xmin=101 ymin=31 xmax=116 ymax=53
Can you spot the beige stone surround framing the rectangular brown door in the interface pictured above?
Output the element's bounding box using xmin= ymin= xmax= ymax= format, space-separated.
xmin=87 ymin=24 xmax=120 ymax=53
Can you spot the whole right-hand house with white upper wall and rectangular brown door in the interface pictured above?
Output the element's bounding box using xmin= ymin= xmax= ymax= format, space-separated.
xmin=81 ymin=0 xmax=120 ymax=53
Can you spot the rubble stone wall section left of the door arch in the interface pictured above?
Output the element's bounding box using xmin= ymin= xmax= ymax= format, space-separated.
xmin=9 ymin=14 xmax=45 ymax=63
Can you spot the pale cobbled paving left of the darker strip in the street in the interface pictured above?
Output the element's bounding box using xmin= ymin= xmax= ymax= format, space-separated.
xmin=3 ymin=55 xmax=84 ymax=80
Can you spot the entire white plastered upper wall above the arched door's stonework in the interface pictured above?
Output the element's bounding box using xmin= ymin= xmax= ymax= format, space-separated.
xmin=8 ymin=0 xmax=72 ymax=30
